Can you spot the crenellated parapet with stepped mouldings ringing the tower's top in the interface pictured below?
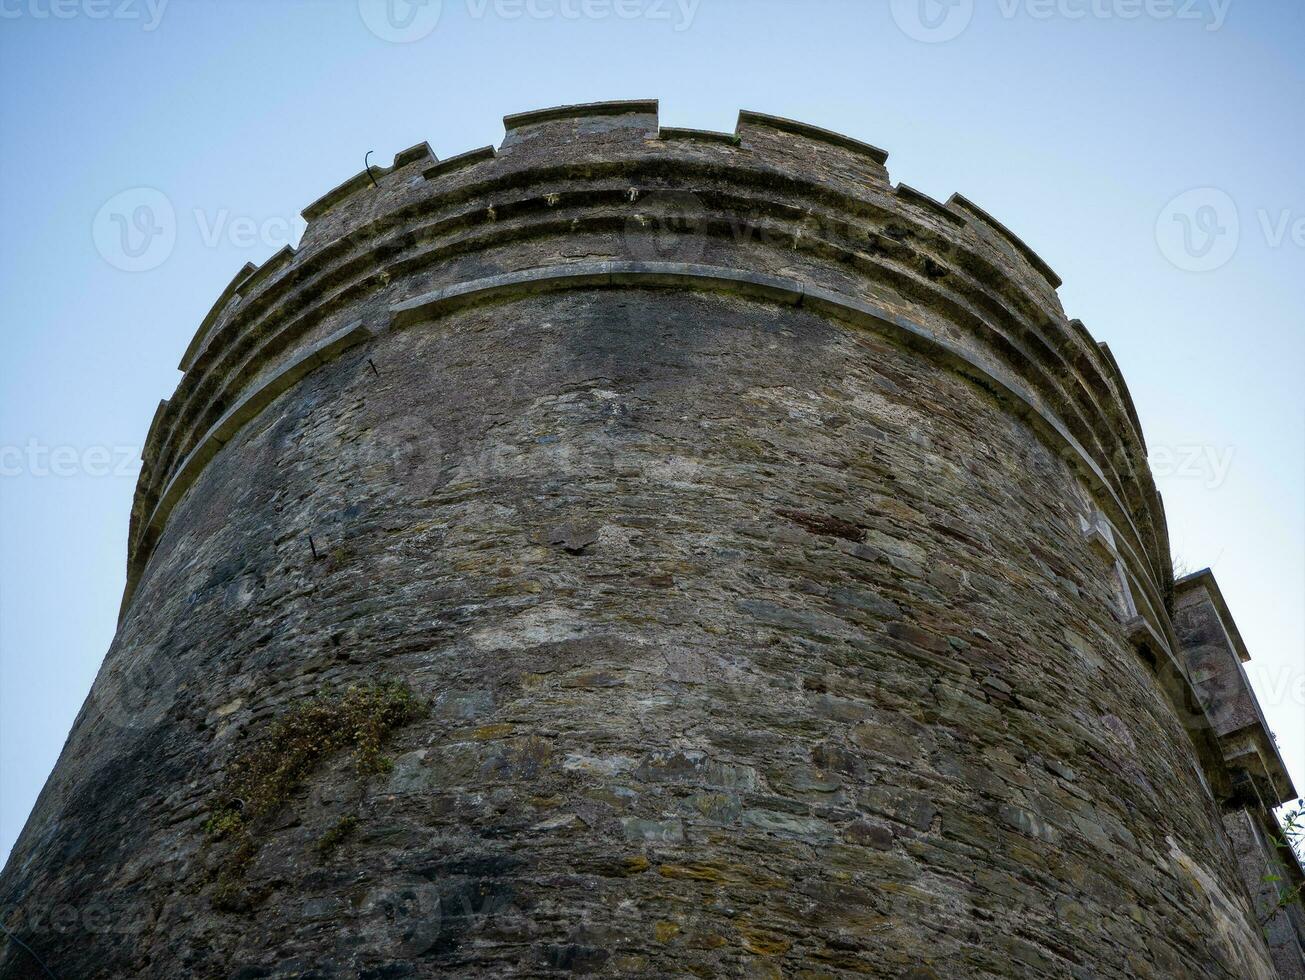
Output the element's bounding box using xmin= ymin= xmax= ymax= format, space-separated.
xmin=124 ymin=102 xmax=1173 ymax=683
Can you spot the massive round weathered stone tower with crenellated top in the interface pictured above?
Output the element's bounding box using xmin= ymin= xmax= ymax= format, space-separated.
xmin=0 ymin=102 xmax=1301 ymax=980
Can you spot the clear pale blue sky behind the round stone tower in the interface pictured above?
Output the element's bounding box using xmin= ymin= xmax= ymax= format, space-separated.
xmin=0 ymin=0 xmax=1305 ymax=856
